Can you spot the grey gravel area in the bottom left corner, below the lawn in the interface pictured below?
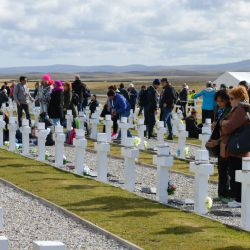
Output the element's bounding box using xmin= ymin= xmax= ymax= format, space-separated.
xmin=0 ymin=183 xmax=126 ymax=250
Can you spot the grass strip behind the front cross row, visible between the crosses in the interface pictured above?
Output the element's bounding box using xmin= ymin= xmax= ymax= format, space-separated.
xmin=88 ymin=139 xmax=218 ymax=182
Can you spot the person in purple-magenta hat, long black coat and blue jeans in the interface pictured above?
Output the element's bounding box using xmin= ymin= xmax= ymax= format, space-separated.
xmin=48 ymin=80 xmax=63 ymax=126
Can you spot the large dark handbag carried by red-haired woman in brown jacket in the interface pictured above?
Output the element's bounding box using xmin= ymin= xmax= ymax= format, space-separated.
xmin=227 ymin=123 xmax=250 ymax=155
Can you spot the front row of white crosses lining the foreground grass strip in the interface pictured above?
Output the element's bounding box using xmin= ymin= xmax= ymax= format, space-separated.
xmin=3 ymin=114 xmax=250 ymax=231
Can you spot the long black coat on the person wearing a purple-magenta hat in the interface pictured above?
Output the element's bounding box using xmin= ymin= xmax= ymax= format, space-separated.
xmin=48 ymin=90 xmax=63 ymax=119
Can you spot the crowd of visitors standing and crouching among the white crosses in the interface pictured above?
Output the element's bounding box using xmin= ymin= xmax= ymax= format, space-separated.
xmin=0 ymin=74 xmax=250 ymax=207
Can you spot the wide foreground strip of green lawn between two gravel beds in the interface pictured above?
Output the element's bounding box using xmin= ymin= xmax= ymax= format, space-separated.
xmin=0 ymin=149 xmax=250 ymax=250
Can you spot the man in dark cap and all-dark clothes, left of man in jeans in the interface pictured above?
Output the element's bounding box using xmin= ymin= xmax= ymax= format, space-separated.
xmin=144 ymin=79 xmax=161 ymax=139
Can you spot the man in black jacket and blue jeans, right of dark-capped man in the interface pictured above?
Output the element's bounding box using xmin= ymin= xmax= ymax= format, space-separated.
xmin=160 ymin=78 xmax=177 ymax=140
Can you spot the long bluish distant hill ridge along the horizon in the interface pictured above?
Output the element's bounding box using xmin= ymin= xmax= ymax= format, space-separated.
xmin=0 ymin=60 xmax=250 ymax=75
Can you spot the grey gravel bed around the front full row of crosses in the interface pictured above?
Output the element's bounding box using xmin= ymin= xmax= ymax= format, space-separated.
xmin=39 ymin=145 xmax=240 ymax=229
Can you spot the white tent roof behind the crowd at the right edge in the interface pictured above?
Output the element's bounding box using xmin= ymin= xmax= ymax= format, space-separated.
xmin=214 ymin=72 xmax=250 ymax=87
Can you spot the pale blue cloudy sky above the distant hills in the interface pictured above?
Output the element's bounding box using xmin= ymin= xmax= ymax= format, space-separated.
xmin=0 ymin=0 xmax=250 ymax=67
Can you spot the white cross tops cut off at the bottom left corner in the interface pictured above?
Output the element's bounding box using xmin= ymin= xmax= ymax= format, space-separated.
xmin=0 ymin=207 xmax=66 ymax=250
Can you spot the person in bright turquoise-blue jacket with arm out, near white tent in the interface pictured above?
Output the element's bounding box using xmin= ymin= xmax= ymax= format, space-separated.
xmin=194 ymin=82 xmax=216 ymax=124
